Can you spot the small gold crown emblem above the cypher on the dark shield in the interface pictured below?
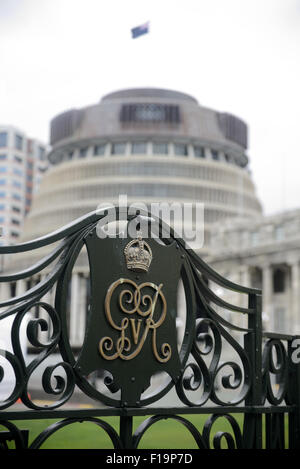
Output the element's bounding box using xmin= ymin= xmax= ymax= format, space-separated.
xmin=124 ymin=233 xmax=152 ymax=272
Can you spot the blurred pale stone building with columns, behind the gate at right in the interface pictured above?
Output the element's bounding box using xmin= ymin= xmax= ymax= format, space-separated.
xmin=207 ymin=210 xmax=300 ymax=334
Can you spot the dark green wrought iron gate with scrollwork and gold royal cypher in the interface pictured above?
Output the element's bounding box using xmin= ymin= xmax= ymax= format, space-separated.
xmin=0 ymin=210 xmax=300 ymax=449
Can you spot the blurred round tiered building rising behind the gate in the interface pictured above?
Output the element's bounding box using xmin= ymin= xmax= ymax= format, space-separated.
xmin=19 ymin=89 xmax=261 ymax=249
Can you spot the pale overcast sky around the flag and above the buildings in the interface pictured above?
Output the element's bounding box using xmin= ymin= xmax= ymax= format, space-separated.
xmin=0 ymin=0 xmax=300 ymax=214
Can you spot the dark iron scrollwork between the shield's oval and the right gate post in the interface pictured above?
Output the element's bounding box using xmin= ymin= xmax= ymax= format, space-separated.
xmin=176 ymin=249 xmax=252 ymax=406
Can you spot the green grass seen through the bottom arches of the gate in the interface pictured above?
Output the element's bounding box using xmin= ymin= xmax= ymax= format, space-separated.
xmin=1 ymin=414 xmax=287 ymax=449
